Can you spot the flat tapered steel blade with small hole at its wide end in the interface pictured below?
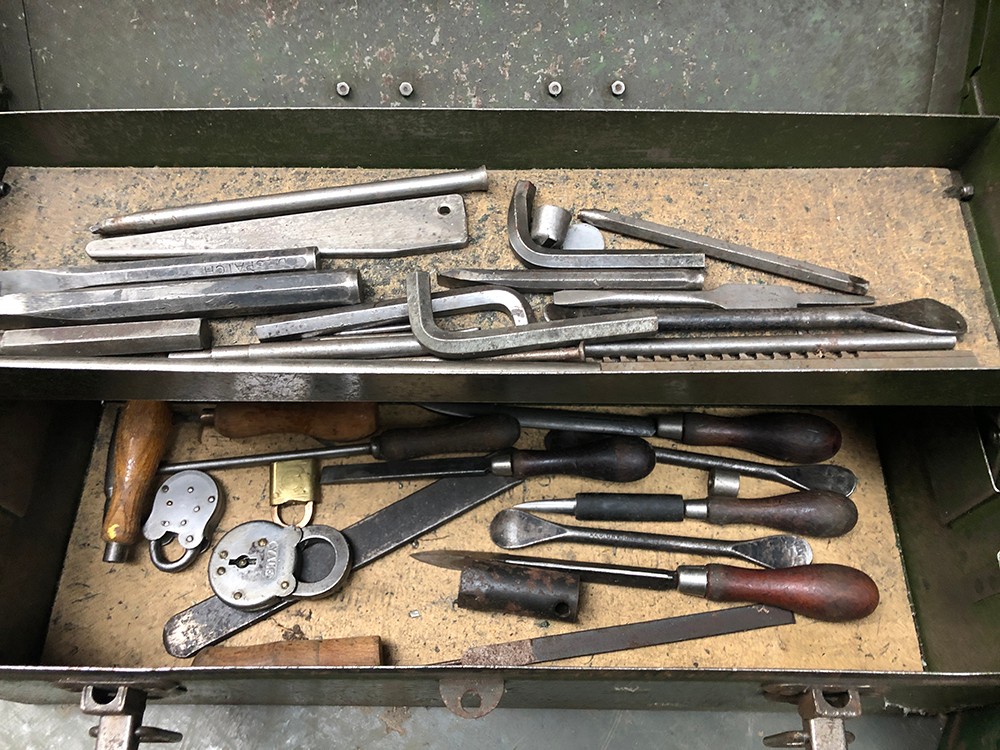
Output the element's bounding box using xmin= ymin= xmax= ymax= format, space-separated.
xmin=87 ymin=195 xmax=469 ymax=260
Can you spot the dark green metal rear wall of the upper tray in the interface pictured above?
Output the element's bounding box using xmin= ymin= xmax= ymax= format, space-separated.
xmin=0 ymin=107 xmax=998 ymax=169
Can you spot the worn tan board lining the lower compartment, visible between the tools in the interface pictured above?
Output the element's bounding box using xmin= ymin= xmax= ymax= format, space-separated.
xmin=43 ymin=406 xmax=921 ymax=670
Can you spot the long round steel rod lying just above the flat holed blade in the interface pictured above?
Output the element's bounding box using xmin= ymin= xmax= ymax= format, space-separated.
xmin=90 ymin=167 xmax=489 ymax=235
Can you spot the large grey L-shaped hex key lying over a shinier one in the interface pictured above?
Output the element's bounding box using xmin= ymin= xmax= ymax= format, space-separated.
xmin=406 ymin=271 xmax=657 ymax=359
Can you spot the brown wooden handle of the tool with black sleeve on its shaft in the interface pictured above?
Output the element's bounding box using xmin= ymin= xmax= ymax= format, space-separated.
xmin=707 ymin=490 xmax=858 ymax=537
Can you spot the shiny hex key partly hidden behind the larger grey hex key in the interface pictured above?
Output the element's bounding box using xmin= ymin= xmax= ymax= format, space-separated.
xmin=254 ymin=286 xmax=535 ymax=341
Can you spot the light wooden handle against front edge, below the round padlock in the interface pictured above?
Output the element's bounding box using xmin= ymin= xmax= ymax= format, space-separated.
xmin=192 ymin=635 xmax=382 ymax=667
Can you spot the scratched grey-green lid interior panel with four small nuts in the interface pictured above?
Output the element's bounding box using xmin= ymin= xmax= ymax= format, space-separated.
xmin=25 ymin=0 xmax=941 ymax=112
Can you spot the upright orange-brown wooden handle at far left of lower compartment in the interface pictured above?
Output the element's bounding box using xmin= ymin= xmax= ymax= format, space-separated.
xmin=101 ymin=401 xmax=172 ymax=545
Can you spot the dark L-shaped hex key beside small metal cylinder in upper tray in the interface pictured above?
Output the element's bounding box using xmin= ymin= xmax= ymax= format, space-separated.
xmin=507 ymin=180 xmax=705 ymax=269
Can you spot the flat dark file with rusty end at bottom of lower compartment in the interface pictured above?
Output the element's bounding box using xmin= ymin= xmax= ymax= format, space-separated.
xmin=459 ymin=606 xmax=795 ymax=667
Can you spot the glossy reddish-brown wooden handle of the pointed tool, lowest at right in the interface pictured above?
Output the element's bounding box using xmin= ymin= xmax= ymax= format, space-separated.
xmin=705 ymin=564 xmax=878 ymax=622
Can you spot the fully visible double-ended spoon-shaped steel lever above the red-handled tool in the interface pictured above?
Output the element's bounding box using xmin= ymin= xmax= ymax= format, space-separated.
xmin=490 ymin=508 xmax=812 ymax=568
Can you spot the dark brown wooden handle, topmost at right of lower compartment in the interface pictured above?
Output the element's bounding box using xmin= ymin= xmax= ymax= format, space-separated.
xmin=682 ymin=413 xmax=841 ymax=464
